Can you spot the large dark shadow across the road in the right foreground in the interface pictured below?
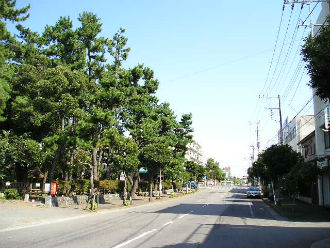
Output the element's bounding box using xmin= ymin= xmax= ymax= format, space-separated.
xmin=153 ymin=224 xmax=329 ymax=248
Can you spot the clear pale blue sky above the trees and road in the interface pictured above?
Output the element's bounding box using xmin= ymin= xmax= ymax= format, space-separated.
xmin=10 ymin=0 xmax=319 ymax=176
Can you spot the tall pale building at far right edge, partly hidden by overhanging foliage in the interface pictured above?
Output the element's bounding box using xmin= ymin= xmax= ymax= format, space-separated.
xmin=313 ymin=2 xmax=330 ymax=207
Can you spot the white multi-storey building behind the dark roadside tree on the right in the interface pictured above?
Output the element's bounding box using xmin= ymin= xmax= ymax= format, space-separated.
xmin=283 ymin=115 xmax=315 ymax=153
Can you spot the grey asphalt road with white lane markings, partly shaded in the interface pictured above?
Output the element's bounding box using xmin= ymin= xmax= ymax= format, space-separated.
xmin=0 ymin=187 xmax=330 ymax=248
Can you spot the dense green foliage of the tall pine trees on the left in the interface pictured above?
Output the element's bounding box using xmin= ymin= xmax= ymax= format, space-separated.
xmin=0 ymin=3 xmax=196 ymax=195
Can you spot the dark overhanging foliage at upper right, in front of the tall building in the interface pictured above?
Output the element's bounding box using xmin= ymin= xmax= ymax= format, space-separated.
xmin=302 ymin=17 xmax=330 ymax=99
